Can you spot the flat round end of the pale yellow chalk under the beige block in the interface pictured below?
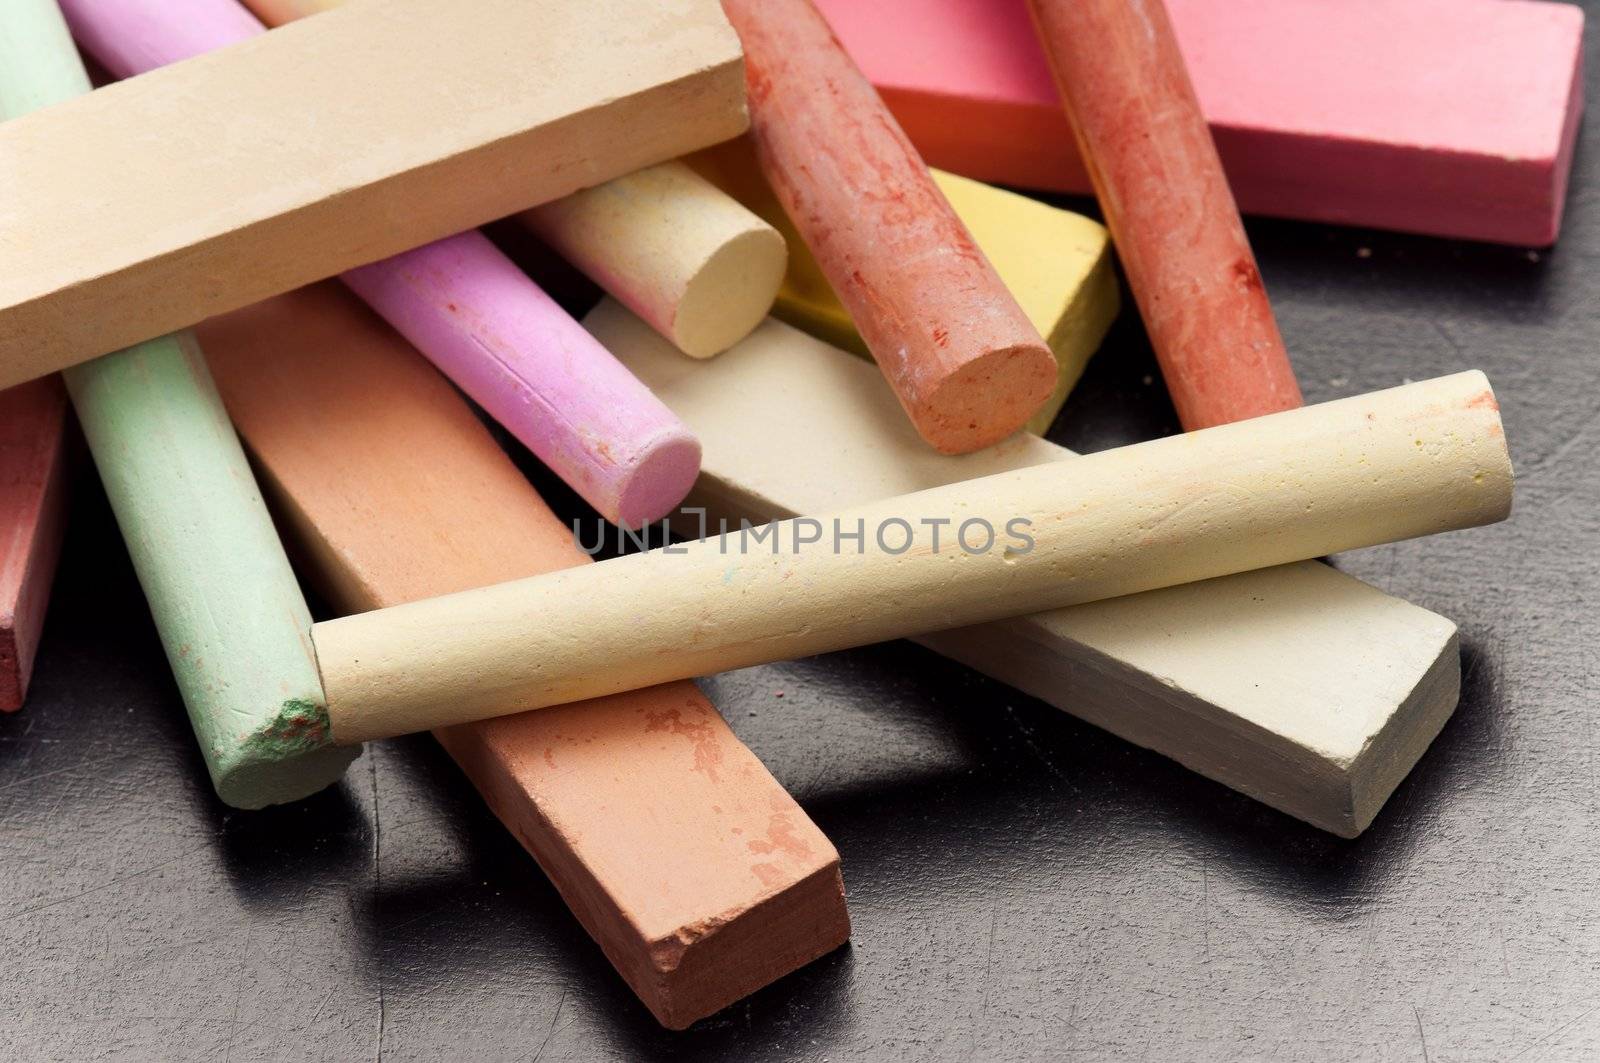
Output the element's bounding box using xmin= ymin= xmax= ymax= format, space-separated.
xmin=672 ymin=225 xmax=789 ymax=359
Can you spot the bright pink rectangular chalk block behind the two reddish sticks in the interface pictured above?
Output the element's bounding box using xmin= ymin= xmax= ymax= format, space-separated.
xmin=818 ymin=0 xmax=1584 ymax=247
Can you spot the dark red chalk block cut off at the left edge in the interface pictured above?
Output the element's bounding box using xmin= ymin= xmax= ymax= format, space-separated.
xmin=0 ymin=376 xmax=67 ymax=712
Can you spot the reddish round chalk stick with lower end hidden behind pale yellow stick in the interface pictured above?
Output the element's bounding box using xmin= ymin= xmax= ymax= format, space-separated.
xmin=1029 ymin=0 xmax=1301 ymax=431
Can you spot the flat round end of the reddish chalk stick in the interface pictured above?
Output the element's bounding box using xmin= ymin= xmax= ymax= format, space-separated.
xmin=910 ymin=343 xmax=1058 ymax=455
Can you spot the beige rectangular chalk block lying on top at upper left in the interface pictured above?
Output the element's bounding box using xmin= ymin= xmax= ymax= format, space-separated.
xmin=0 ymin=0 xmax=746 ymax=386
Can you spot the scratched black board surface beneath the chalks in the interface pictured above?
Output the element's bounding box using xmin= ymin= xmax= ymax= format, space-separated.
xmin=0 ymin=14 xmax=1600 ymax=1063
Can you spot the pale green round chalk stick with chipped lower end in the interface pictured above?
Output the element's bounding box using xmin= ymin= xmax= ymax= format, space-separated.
xmin=0 ymin=0 xmax=360 ymax=808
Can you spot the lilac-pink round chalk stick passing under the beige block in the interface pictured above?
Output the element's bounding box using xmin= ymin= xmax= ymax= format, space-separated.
xmin=61 ymin=0 xmax=701 ymax=528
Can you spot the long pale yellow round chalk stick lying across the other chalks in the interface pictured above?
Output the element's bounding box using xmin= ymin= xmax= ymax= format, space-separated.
xmin=312 ymin=371 xmax=1512 ymax=743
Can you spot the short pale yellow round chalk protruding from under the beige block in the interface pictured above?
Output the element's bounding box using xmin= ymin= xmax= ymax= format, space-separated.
xmin=518 ymin=162 xmax=789 ymax=359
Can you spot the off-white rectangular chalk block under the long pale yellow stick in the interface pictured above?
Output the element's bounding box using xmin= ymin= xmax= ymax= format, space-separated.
xmin=584 ymin=301 xmax=1461 ymax=837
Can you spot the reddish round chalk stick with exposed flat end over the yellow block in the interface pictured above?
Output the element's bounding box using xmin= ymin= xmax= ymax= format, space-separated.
xmin=723 ymin=0 xmax=1056 ymax=453
